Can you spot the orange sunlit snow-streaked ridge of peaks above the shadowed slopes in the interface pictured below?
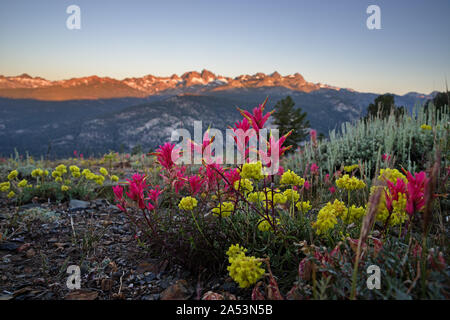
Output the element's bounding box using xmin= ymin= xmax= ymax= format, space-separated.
xmin=0 ymin=70 xmax=356 ymax=101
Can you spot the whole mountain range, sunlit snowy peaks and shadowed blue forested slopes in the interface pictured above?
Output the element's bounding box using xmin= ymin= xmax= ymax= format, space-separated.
xmin=0 ymin=70 xmax=435 ymax=157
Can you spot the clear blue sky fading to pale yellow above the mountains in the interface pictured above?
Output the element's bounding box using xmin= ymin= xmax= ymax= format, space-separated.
xmin=0 ymin=0 xmax=450 ymax=94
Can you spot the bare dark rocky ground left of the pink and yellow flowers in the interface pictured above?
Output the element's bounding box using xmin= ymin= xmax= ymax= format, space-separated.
xmin=0 ymin=200 xmax=241 ymax=300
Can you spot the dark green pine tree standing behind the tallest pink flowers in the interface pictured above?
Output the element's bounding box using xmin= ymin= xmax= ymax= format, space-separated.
xmin=272 ymin=96 xmax=309 ymax=150
